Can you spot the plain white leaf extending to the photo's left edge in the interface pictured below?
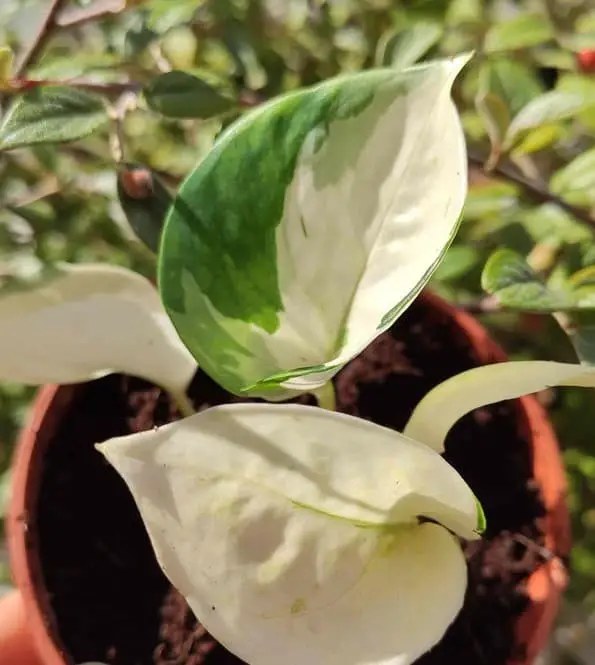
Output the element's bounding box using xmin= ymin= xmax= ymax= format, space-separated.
xmin=0 ymin=264 xmax=196 ymax=392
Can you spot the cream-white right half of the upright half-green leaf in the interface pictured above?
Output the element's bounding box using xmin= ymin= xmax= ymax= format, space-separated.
xmin=266 ymin=58 xmax=467 ymax=390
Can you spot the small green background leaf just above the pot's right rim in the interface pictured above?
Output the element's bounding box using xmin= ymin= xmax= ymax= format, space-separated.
xmin=481 ymin=249 xmax=576 ymax=312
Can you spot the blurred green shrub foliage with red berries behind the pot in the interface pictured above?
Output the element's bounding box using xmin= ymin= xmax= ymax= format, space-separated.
xmin=0 ymin=0 xmax=595 ymax=662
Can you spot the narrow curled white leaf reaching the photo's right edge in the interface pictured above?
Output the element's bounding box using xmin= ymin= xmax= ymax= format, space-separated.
xmin=404 ymin=360 xmax=595 ymax=452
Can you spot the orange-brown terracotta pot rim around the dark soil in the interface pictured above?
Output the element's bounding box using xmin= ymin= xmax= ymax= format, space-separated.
xmin=0 ymin=292 xmax=571 ymax=665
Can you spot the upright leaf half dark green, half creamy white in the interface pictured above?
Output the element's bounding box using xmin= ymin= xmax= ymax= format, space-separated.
xmin=159 ymin=56 xmax=468 ymax=399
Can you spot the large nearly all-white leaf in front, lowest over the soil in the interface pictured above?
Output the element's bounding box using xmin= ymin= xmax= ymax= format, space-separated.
xmin=98 ymin=404 xmax=484 ymax=665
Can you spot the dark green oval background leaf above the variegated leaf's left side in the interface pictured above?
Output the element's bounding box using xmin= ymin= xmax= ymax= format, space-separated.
xmin=144 ymin=71 xmax=234 ymax=118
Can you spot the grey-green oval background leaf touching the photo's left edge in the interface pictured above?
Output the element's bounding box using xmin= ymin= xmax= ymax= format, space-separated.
xmin=0 ymin=86 xmax=109 ymax=150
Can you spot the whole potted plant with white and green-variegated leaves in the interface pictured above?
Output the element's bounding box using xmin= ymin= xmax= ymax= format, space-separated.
xmin=0 ymin=56 xmax=595 ymax=665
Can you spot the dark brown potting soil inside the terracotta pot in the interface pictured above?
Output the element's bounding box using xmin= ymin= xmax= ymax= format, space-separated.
xmin=32 ymin=301 xmax=543 ymax=665
